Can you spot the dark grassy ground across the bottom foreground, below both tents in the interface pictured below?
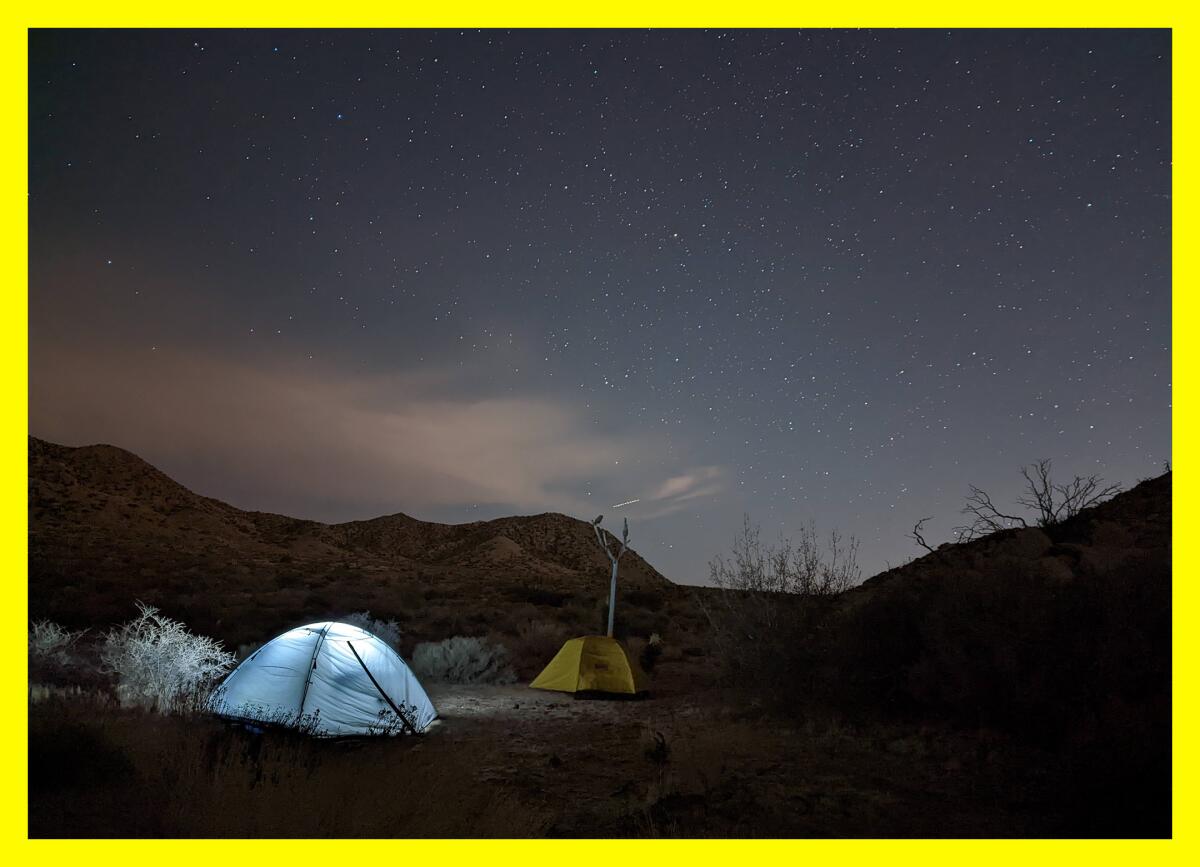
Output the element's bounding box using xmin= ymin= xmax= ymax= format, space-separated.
xmin=30 ymin=686 xmax=1152 ymax=837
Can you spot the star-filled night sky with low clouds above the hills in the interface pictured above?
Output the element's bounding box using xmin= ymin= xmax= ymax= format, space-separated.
xmin=30 ymin=30 xmax=1171 ymax=582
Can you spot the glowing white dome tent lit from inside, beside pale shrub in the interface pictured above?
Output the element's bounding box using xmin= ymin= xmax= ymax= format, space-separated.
xmin=209 ymin=621 xmax=438 ymax=737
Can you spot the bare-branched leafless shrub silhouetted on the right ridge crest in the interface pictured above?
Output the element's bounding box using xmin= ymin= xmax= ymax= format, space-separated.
xmin=950 ymin=459 xmax=1121 ymax=542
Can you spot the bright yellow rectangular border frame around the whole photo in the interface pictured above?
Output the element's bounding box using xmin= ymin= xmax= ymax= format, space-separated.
xmin=7 ymin=0 xmax=1200 ymax=867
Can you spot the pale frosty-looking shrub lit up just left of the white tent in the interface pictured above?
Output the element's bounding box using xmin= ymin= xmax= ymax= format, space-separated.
xmin=101 ymin=602 xmax=235 ymax=712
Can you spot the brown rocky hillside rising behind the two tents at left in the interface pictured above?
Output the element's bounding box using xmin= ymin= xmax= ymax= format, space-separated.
xmin=29 ymin=437 xmax=677 ymax=641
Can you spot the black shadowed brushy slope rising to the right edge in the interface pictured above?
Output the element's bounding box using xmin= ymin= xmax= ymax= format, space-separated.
xmin=710 ymin=473 xmax=1171 ymax=837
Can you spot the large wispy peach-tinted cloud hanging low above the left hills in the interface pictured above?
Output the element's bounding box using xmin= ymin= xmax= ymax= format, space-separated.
xmin=30 ymin=352 xmax=691 ymax=519
